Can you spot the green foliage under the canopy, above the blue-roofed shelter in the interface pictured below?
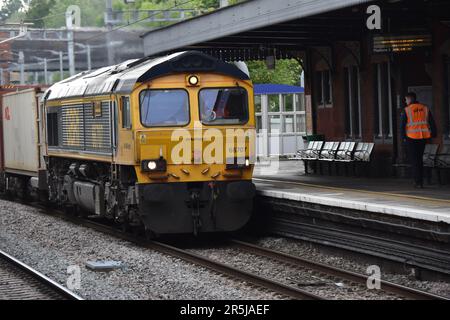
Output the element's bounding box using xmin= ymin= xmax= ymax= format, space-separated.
xmin=247 ymin=59 xmax=302 ymax=86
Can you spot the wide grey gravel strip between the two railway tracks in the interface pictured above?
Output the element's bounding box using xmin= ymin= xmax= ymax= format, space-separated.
xmin=0 ymin=200 xmax=281 ymax=300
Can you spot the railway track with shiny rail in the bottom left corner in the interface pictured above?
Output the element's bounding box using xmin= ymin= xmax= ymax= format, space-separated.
xmin=0 ymin=250 xmax=82 ymax=300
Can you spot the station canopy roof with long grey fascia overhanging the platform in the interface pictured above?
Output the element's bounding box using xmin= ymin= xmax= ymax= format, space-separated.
xmin=142 ymin=0 xmax=450 ymax=61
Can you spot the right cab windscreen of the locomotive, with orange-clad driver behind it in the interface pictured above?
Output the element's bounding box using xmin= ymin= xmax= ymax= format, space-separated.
xmin=199 ymin=88 xmax=249 ymax=125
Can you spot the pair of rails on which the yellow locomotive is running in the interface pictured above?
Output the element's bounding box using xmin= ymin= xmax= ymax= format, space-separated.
xmin=24 ymin=202 xmax=448 ymax=300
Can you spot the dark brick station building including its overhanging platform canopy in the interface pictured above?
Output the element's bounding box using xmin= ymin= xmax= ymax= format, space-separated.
xmin=143 ymin=0 xmax=450 ymax=180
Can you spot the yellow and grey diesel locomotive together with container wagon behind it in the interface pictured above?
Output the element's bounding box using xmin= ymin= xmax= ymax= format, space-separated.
xmin=2 ymin=51 xmax=255 ymax=235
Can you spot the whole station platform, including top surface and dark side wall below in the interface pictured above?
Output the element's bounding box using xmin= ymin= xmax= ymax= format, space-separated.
xmin=252 ymin=161 xmax=450 ymax=278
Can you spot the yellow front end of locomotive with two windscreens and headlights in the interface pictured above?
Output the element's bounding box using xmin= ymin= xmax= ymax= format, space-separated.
xmin=128 ymin=73 xmax=256 ymax=184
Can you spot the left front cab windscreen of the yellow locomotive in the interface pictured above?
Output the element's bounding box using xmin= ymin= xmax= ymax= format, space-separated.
xmin=140 ymin=89 xmax=190 ymax=127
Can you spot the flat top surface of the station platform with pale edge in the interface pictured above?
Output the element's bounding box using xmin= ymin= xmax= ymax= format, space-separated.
xmin=254 ymin=160 xmax=450 ymax=225
